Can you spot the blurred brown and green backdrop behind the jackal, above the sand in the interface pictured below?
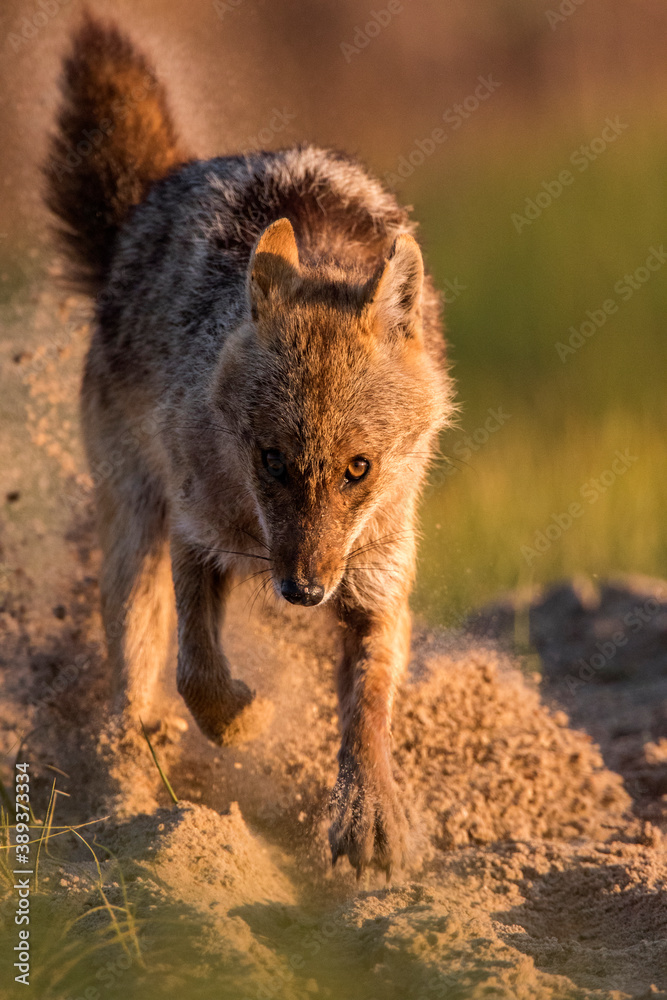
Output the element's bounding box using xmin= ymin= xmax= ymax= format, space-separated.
xmin=0 ymin=0 xmax=667 ymax=623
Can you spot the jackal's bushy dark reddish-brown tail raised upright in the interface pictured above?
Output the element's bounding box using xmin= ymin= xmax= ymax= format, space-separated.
xmin=44 ymin=14 xmax=188 ymax=294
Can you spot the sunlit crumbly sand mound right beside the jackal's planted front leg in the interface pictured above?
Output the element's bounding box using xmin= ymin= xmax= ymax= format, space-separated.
xmin=395 ymin=648 xmax=630 ymax=848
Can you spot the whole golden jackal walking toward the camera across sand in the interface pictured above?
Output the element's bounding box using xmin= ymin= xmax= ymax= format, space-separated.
xmin=45 ymin=16 xmax=452 ymax=872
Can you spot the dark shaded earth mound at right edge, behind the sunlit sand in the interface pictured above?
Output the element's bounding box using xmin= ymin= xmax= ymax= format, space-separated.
xmin=471 ymin=576 xmax=667 ymax=825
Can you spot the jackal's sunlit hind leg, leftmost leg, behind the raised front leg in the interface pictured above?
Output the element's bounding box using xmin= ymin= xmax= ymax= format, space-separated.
xmin=91 ymin=455 xmax=181 ymax=815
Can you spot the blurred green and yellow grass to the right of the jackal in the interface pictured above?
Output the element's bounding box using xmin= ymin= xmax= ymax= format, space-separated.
xmin=412 ymin=123 xmax=667 ymax=623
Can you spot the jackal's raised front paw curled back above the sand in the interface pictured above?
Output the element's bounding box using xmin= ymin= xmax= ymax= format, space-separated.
xmin=183 ymin=680 xmax=274 ymax=747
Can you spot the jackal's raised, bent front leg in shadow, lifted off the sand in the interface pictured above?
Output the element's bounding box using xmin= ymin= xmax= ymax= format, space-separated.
xmin=171 ymin=539 xmax=271 ymax=746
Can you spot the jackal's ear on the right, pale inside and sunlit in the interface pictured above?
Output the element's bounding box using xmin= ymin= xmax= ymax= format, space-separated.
xmin=365 ymin=233 xmax=424 ymax=337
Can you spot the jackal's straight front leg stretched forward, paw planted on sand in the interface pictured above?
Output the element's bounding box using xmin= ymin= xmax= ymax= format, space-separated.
xmin=329 ymin=601 xmax=410 ymax=878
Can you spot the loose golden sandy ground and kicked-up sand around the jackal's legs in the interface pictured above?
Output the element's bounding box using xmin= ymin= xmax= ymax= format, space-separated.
xmin=0 ymin=286 xmax=667 ymax=1000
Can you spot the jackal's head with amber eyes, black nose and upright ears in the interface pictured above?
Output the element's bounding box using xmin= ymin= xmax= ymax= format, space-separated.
xmin=215 ymin=219 xmax=447 ymax=605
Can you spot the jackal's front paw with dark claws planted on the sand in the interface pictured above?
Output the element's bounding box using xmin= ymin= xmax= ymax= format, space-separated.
xmin=329 ymin=756 xmax=408 ymax=881
